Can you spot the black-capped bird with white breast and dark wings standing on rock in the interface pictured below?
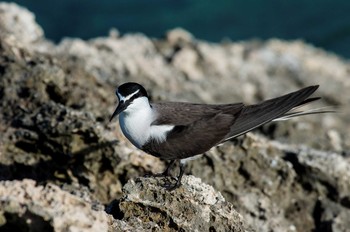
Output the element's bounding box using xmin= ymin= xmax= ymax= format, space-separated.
xmin=110 ymin=82 xmax=330 ymax=191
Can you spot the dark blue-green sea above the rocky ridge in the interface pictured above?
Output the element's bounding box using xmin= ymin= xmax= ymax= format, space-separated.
xmin=8 ymin=0 xmax=350 ymax=58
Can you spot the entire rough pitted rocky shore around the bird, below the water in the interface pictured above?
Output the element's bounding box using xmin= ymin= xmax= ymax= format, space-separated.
xmin=0 ymin=3 xmax=350 ymax=231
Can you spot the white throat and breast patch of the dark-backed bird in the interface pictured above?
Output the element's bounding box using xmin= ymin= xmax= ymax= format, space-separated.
xmin=119 ymin=97 xmax=174 ymax=148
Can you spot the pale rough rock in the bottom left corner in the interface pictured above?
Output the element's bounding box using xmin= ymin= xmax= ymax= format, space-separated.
xmin=0 ymin=180 xmax=109 ymax=231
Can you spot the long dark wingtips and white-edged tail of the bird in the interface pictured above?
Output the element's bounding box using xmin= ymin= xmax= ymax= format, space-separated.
xmin=221 ymin=85 xmax=333 ymax=142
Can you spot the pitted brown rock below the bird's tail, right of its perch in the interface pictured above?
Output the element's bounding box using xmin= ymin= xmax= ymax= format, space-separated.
xmin=187 ymin=133 xmax=350 ymax=231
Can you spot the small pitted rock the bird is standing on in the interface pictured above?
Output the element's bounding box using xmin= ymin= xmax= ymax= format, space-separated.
xmin=111 ymin=176 xmax=252 ymax=231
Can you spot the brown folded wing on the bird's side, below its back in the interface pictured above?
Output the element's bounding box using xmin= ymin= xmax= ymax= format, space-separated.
xmin=142 ymin=113 xmax=235 ymax=160
